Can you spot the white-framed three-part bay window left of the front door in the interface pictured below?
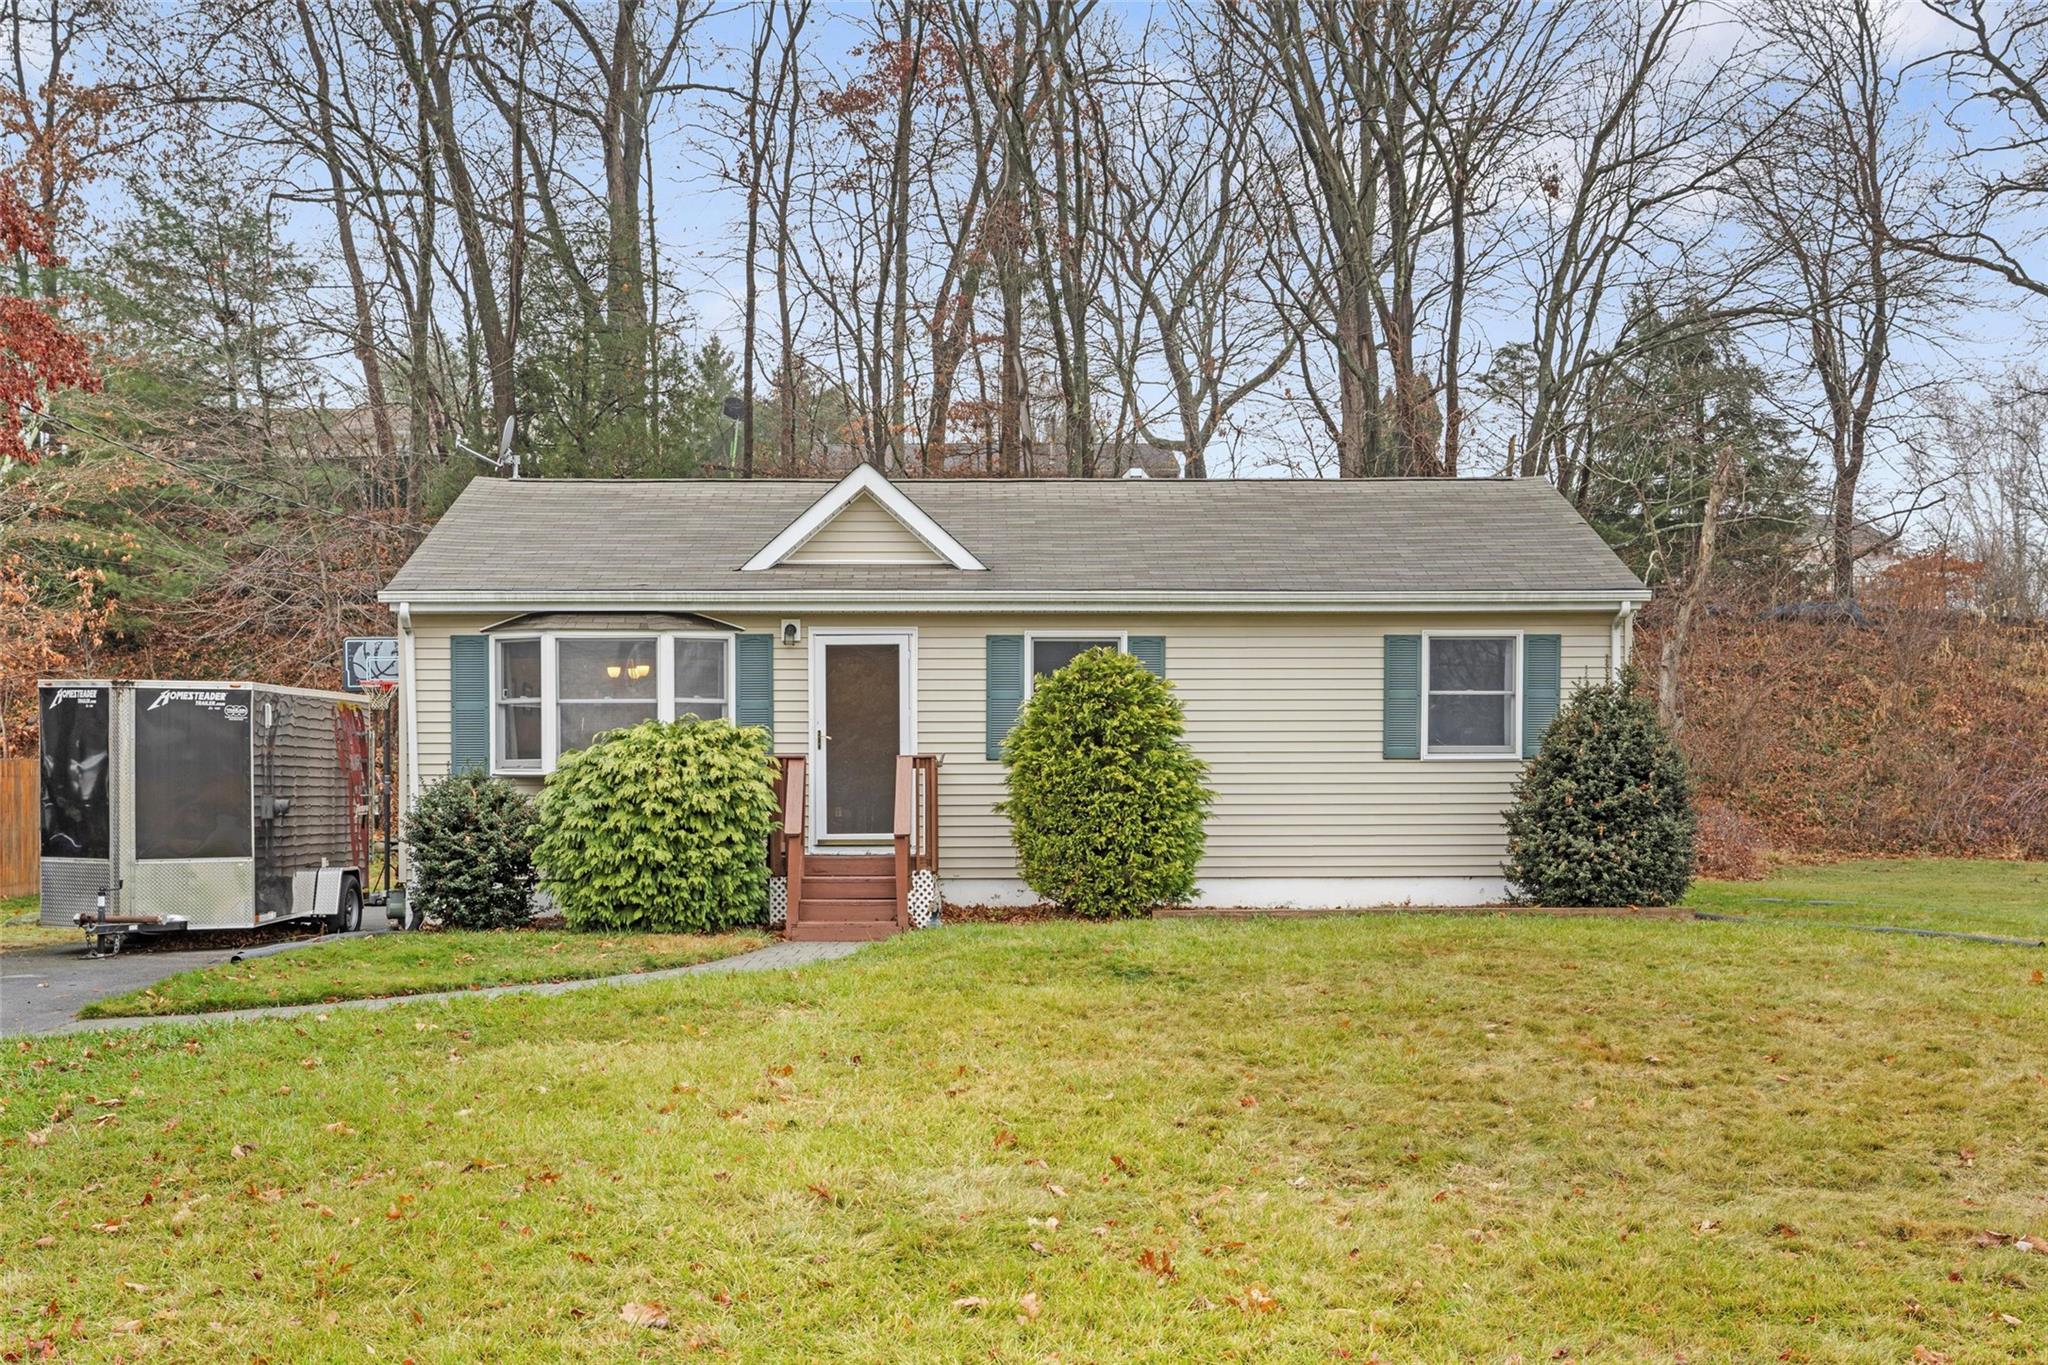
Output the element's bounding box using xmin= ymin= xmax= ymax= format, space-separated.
xmin=492 ymin=632 xmax=733 ymax=774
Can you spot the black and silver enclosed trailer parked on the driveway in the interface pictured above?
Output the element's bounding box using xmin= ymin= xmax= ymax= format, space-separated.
xmin=39 ymin=679 xmax=373 ymax=954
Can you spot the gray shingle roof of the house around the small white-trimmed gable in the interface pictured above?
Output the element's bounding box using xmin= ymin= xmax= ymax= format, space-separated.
xmin=381 ymin=479 xmax=1647 ymax=606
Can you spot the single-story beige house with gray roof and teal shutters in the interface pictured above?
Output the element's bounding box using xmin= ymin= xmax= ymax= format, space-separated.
xmin=381 ymin=467 xmax=1649 ymax=935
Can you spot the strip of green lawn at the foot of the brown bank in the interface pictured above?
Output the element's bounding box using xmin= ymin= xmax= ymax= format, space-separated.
xmin=1686 ymin=857 xmax=2048 ymax=937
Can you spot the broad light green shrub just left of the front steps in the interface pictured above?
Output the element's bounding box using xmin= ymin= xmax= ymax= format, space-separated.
xmin=535 ymin=718 xmax=776 ymax=933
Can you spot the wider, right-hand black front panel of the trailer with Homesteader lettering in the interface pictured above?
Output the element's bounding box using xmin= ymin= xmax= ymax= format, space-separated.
xmin=135 ymin=688 xmax=252 ymax=857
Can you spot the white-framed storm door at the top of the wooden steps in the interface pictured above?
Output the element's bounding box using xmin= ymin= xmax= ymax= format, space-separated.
xmin=811 ymin=634 xmax=909 ymax=843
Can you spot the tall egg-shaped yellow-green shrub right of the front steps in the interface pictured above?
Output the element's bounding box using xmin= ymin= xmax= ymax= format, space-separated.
xmin=997 ymin=649 xmax=1212 ymax=919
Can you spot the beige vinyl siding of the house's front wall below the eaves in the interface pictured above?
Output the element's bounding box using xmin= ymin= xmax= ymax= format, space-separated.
xmin=399 ymin=612 xmax=1614 ymax=878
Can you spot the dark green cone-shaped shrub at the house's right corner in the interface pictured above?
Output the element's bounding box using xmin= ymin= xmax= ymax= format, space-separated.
xmin=1505 ymin=671 xmax=1698 ymax=905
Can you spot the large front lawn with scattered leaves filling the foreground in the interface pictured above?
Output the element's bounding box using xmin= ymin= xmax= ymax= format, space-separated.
xmin=0 ymin=866 xmax=2048 ymax=1363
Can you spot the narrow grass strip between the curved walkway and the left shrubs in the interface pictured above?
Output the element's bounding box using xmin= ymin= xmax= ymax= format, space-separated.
xmin=80 ymin=929 xmax=772 ymax=1019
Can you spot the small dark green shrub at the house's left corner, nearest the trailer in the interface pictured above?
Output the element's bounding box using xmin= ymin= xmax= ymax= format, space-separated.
xmin=406 ymin=772 xmax=537 ymax=929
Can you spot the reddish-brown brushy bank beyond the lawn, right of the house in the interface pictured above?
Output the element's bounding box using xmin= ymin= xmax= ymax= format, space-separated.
xmin=1638 ymin=606 xmax=2048 ymax=876
